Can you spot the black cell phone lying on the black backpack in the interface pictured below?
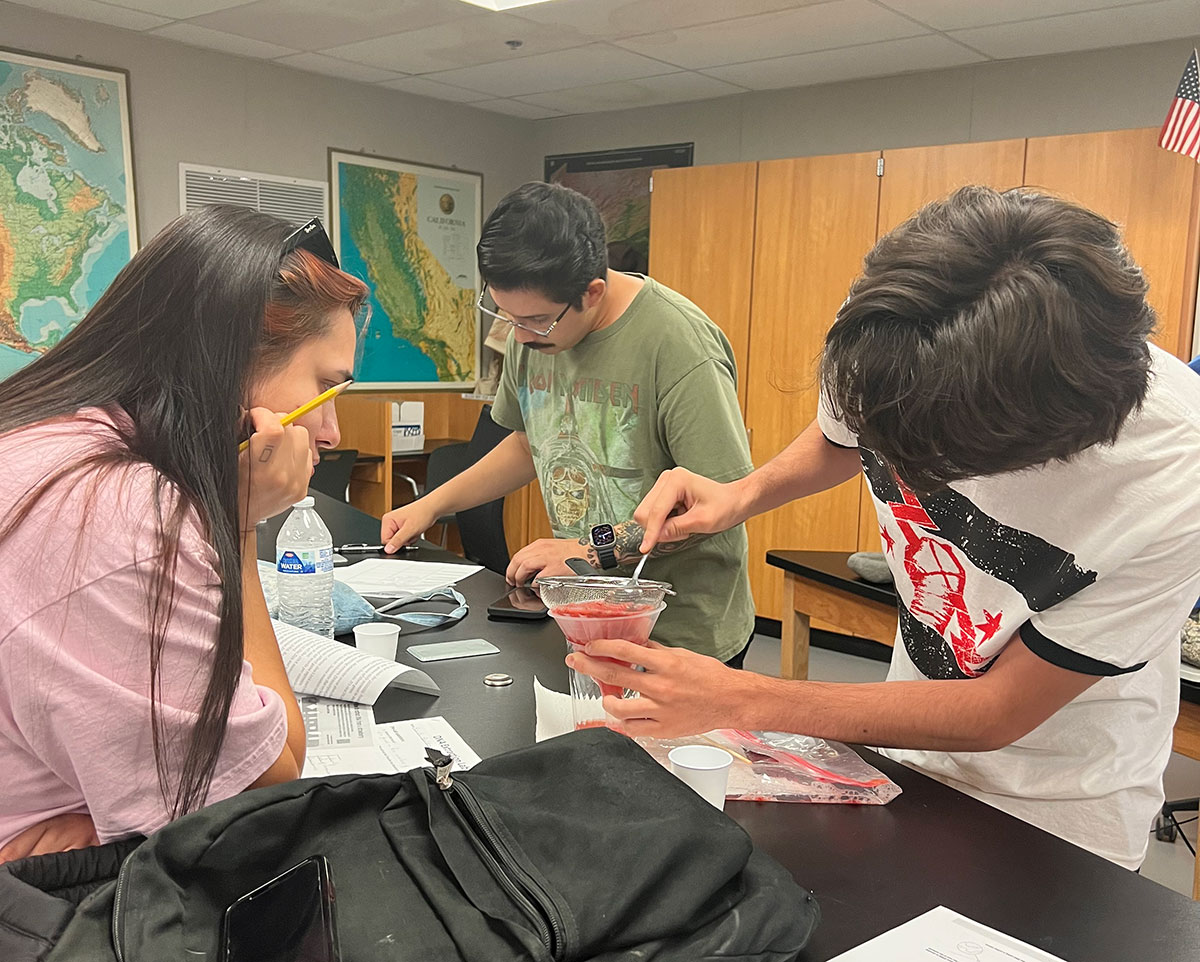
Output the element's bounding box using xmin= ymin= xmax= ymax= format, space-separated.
xmin=218 ymin=855 xmax=342 ymax=962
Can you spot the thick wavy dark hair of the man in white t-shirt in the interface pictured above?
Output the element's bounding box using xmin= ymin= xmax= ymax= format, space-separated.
xmin=821 ymin=187 xmax=1154 ymax=492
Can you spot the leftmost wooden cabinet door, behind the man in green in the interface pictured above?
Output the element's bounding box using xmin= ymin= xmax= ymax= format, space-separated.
xmin=650 ymin=163 xmax=758 ymax=415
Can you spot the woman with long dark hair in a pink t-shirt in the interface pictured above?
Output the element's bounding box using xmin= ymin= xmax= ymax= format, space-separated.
xmin=0 ymin=206 xmax=367 ymax=856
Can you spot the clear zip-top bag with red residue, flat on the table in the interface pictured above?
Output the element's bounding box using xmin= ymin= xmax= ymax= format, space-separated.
xmin=637 ymin=728 xmax=901 ymax=805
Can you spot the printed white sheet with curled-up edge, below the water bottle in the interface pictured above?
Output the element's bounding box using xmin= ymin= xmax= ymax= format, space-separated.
xmin=271 ymin=619 xmax=442 ymax=705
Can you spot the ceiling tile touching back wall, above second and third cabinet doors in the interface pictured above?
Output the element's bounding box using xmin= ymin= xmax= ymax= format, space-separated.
xmin=704 ymin=34 xmax=985 ymax=90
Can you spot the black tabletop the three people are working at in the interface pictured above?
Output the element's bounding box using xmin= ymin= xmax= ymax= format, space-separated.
xmin=259 ymin=494 xmax=1200 ymax=962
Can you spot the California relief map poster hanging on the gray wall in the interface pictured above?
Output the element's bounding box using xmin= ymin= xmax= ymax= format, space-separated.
xmin=329 ymin=150 xmax=482 ymax=390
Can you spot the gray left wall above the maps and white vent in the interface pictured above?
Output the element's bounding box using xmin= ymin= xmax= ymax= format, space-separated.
xmin=0 ymin=2 xmax=539 ymax=241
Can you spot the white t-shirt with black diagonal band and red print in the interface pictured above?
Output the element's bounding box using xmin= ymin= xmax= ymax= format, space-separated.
xmin=817 ymin=347 xmax=1200 ymax=868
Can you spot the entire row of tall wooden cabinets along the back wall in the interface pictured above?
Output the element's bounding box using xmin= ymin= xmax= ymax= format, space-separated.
xmin=650 ymin=130 xmax=1200 ymax=618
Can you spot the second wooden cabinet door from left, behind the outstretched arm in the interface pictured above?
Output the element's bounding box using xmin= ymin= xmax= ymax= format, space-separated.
xmin=739 ymin=151 xmax=880 ymax=618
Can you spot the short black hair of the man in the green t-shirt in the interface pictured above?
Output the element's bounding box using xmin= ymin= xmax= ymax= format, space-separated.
xmin=475 ymin=181 xmax=608 ymax=309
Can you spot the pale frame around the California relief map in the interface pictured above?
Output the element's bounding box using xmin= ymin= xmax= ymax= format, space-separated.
xmin=328 ymin=148 xmax=484 ymax=392
